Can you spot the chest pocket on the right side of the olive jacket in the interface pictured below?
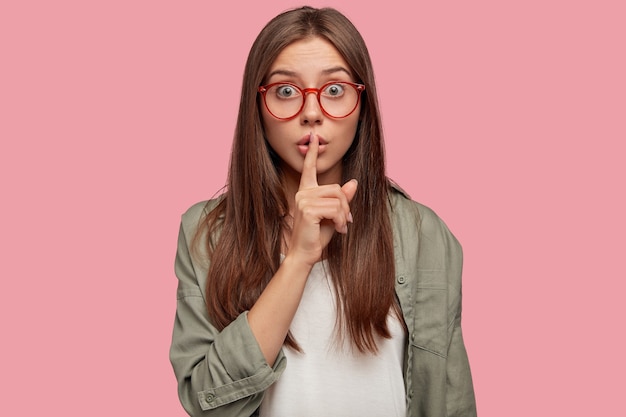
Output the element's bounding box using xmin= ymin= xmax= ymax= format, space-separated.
xmin=411 ymin=270 xmax=448 ymax=358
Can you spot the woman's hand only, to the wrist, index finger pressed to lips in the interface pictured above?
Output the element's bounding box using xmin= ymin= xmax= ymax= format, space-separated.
xmin=288 ymin=134 xmax=357 ymax=266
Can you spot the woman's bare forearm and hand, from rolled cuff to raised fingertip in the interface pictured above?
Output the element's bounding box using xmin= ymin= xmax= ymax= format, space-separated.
xmin=248 ymin=135 xmax=357 ymax=366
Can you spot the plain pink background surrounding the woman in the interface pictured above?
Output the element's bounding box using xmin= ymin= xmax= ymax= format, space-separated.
xmin=0 ymin=0 xmax=626 ymax=417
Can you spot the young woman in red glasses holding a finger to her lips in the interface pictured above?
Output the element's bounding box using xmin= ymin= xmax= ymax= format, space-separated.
xmin=170 ymin=7 xmax=475 ymax=417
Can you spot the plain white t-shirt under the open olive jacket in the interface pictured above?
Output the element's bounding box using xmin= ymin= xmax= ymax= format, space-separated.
xmin=260 ymin=261 xmax=406 ymax=417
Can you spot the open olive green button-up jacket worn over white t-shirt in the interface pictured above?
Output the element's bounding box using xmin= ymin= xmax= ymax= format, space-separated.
xmin=170 ymin=189 xmax=476 ymax=417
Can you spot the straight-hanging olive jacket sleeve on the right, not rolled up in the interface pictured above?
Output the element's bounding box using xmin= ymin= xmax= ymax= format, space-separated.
xmin=410 ymin=200 xmax=476 ymax=417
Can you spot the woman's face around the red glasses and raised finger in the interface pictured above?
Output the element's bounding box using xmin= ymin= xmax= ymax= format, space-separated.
xmin=260 ymin=37 xmax=360 ymax=184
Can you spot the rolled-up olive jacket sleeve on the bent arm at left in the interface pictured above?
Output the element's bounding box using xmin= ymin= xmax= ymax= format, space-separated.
xmin=170 ymin=206 xmax=286 ymax=417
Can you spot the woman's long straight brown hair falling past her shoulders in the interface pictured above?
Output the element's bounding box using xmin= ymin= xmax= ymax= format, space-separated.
xmin=198 ymin=7 xmax=400 ymax=352
